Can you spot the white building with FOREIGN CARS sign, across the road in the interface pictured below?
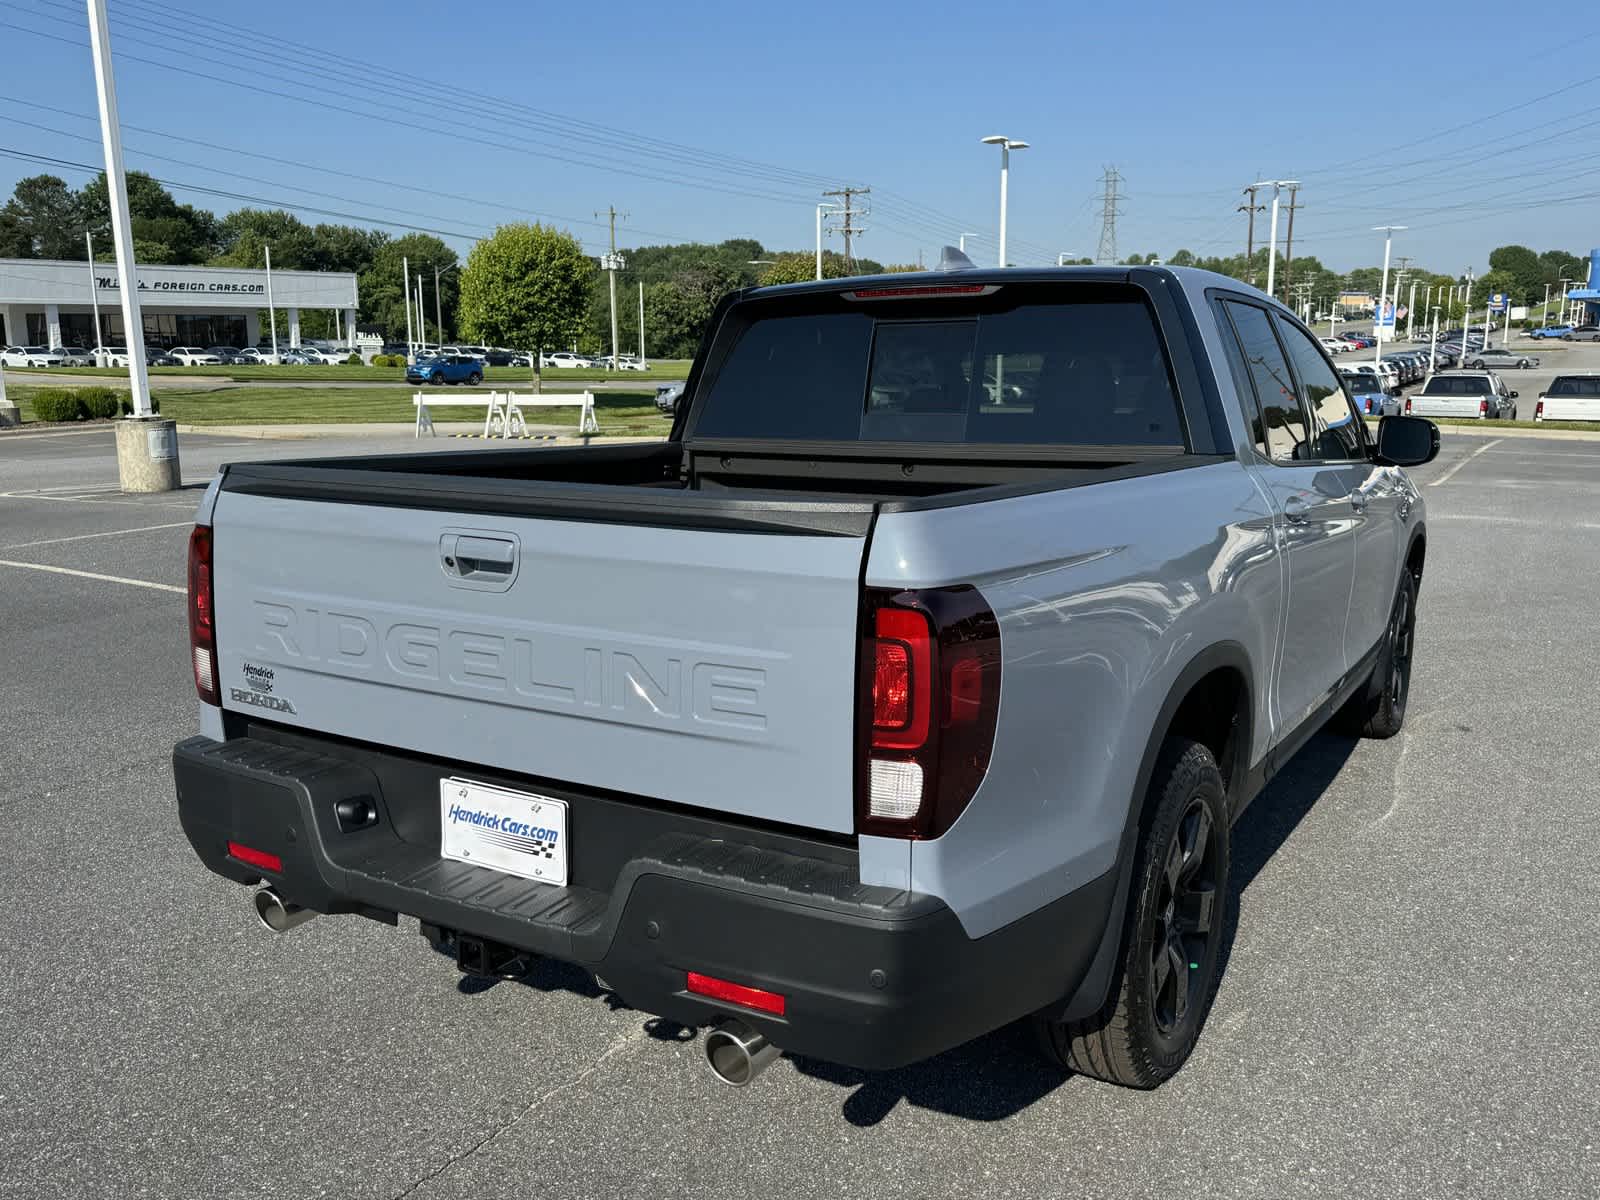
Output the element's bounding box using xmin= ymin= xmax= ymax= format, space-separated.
xmin=0 ymin=258 xmax=357 ymax=349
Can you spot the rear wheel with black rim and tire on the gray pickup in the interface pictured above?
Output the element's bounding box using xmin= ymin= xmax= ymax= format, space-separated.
xmin=1035 ymin=738 xmax=1229 ymax=1088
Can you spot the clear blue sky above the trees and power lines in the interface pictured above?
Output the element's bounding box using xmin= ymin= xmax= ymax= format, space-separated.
xmin=0 ymin=0 xmax=1600 ymax=272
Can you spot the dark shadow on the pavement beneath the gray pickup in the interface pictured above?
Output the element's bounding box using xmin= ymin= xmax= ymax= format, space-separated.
xmin=458 ymin=733 xmax=1357 ymax=1128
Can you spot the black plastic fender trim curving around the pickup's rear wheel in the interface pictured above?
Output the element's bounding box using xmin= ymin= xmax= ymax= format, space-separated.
xmin=1053 ymin=642 xmax=1264 ymax=1021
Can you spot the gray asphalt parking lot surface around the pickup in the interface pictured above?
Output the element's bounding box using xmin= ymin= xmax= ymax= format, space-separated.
xmin=0 ymin=428 xmax=1600 ymax=1200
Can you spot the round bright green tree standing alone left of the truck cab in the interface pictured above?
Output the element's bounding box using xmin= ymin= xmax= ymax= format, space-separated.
xmin=460 ymin=221 xmax=594 ymax=350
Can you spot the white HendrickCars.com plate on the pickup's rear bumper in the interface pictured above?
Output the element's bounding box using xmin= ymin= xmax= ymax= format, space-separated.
xmin=438 ymin=779 xmax=566 ymax=888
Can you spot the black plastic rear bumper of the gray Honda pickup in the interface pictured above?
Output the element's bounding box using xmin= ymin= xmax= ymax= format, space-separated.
xmin=173 ymin=738 xmax=1114 ymax=1069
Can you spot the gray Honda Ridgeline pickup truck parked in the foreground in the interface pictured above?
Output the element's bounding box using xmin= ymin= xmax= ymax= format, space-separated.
xmin=174 ymin=267 xmax=1438 ymax=1086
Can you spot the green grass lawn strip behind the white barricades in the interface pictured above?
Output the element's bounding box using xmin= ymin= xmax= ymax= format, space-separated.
xmin=6 ymin=384 xmax=669 ymax=437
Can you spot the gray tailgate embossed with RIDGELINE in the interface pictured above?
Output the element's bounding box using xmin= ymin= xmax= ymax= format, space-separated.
xmin=213 ymin=488 xmax=866 ymax=832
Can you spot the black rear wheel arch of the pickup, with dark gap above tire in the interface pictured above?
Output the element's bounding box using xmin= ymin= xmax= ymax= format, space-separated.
xmin=1056 ymin=642 xmax=1258 ymax=1021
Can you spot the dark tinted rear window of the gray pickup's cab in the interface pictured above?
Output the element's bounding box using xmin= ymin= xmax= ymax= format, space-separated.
xmin=694 ymin=285 xmax=1186 ymax=450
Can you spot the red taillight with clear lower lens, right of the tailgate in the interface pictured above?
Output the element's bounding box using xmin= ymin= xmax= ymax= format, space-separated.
xmin=856 ymin=587 xmax=1000 ymax=838
